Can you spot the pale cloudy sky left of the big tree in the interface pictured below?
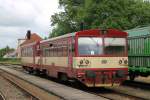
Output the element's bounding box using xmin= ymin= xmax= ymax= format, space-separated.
xmin=0 ymin=0 xmax=61 ymax=48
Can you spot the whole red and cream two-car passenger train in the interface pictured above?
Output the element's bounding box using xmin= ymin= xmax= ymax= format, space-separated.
xmin=22 ymin=29 xmax=128 ymax=87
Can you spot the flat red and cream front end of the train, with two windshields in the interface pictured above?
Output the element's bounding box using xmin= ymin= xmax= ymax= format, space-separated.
xmin=73 ymin=29 xmax=128 ymax=87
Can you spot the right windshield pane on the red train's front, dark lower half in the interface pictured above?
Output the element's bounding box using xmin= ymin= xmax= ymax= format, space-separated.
xmin=104 ymin=38 xmax=126 ymax=56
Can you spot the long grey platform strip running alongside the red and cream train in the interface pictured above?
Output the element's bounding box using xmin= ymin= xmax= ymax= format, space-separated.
xmin=0 ymin=66 xmax=108 ymax=100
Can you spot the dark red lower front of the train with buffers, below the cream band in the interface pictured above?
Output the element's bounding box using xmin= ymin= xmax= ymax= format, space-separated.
xmin=77 ymin=70 xmax=128 ymax=87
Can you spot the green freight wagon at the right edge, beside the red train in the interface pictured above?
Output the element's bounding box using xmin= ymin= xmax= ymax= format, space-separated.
xmin=126 ymin=26 xmax=150 ymax=80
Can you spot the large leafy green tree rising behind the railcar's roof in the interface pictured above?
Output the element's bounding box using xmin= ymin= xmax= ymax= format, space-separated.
xmin=50 ymin=0 xmax=150 ymax=37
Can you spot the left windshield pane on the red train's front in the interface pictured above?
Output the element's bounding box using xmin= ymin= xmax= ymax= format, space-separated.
xmin=78 ymin=37 xmax=103 ymax=55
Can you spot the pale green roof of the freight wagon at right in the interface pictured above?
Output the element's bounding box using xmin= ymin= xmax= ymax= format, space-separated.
xmin=125 ymin=26 xmax=150 ymax=37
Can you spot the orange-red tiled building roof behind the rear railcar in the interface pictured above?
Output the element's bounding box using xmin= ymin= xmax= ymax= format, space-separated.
xmin=20 ymin=33 xmax=42 ymax=46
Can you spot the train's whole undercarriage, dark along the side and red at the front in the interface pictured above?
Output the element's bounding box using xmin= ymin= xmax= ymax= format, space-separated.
xmin=23 ymin=66 xmax=128 ymax=87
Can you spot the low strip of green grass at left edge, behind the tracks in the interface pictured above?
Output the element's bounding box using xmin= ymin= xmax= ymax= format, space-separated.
xmin=0 ymin=58 xmax=21 ymax=64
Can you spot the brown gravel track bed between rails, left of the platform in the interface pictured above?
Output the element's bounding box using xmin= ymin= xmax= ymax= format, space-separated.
xmin=0 ymin=68 xmax=59 ymax=100
